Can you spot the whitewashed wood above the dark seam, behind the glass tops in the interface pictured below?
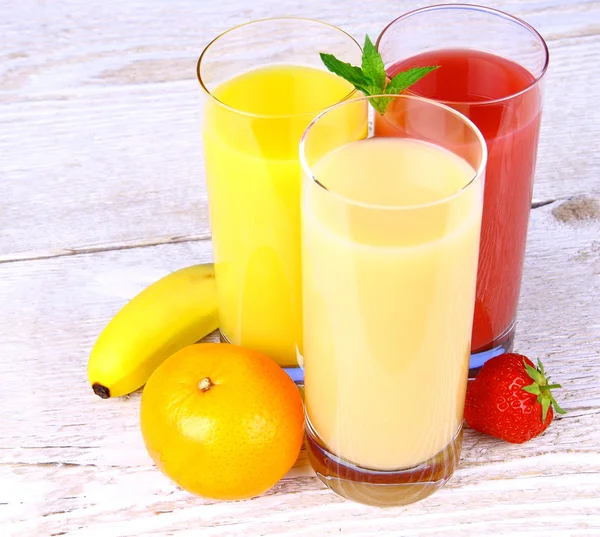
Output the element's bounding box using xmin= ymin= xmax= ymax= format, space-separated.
xmin=0 ymin=0 xmax=600 ymax=261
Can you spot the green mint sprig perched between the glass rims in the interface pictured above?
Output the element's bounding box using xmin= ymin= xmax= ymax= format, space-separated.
xmin=320 ymin=35 xmax=439 ymax=115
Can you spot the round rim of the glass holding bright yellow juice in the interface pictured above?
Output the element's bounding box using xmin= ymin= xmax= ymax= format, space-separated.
xmin=196 ymin=17 xmax=362 ymax=119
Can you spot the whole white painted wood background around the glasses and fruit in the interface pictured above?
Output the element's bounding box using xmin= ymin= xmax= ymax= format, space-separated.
xmin=0 ymin=0 xmax=600 ymax=537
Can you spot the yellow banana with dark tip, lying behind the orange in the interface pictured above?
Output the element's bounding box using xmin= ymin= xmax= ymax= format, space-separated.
xmin=88 ymin=264 xmax=218 ymax=399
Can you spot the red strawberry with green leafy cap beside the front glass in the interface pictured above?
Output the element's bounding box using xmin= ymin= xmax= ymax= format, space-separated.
xmin=465 ymin=353 xmax=565 ymax=444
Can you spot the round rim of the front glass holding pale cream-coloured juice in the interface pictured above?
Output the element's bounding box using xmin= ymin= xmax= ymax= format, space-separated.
xmin=299 ymin=94 xmax=488 ymax=211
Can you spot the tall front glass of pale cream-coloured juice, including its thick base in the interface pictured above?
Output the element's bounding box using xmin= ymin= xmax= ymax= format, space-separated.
xmin=300 ymin=96 xmax=486 ymax=506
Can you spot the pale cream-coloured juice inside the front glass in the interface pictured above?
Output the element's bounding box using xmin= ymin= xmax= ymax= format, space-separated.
xmin=302 ymin=138 xmax=482 ymax=470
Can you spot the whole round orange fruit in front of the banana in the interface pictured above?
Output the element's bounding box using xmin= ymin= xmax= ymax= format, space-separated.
xmin=141 ymin=343 xmax=304 ymax=500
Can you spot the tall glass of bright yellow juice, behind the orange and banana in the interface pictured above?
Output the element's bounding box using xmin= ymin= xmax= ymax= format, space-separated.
xmin=197 ymin=18 xmax=361 ymax=381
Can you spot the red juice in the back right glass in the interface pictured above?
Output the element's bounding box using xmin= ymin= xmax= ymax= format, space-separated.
xmin=383 ymin=49 xmax=542 ymax=353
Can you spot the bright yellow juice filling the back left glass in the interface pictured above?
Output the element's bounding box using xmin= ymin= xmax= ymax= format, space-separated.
xmin=203 ymin=65 xmax=352 ymax=366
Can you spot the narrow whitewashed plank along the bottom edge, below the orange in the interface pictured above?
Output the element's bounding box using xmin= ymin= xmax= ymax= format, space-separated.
xmin=3 ymin=462 xmax=600 ymax=537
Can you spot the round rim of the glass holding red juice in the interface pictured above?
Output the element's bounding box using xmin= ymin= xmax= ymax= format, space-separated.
xmin=375 ymin=3 xmax=550 ymax=106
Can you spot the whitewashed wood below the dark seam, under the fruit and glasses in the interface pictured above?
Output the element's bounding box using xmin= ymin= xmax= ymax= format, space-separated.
xmin=0 ymin=202 xmax=600 ymax=537
